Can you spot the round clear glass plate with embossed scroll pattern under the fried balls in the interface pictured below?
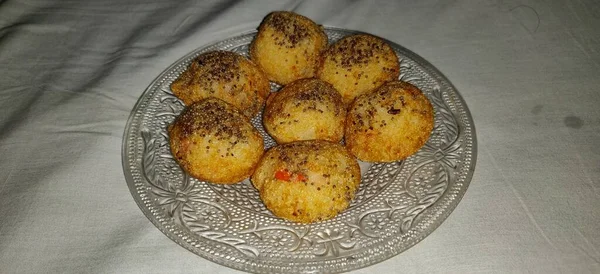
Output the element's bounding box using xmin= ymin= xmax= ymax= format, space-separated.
xmin=122 ymin=27 xmax=476 ymax=273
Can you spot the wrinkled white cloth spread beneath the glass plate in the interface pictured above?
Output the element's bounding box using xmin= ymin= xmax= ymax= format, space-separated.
xmin=0 ymin=0 xmax=600 ymax=273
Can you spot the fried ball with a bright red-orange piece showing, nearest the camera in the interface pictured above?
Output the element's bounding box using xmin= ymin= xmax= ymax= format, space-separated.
xmin=251 ymin=140 xmax=360 ymax=223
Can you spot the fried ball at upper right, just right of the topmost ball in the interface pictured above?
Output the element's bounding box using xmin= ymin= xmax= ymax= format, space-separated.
xmin=317 ymin=34 xmax=400 ymax=105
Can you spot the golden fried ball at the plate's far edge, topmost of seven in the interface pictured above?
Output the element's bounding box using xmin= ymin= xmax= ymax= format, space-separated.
xmin=250 ymin=11 xmax=327 ymax=85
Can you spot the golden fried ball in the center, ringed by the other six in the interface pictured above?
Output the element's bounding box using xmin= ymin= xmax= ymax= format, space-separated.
xmin=263 ymin=78 xmax=346 ymax=143
